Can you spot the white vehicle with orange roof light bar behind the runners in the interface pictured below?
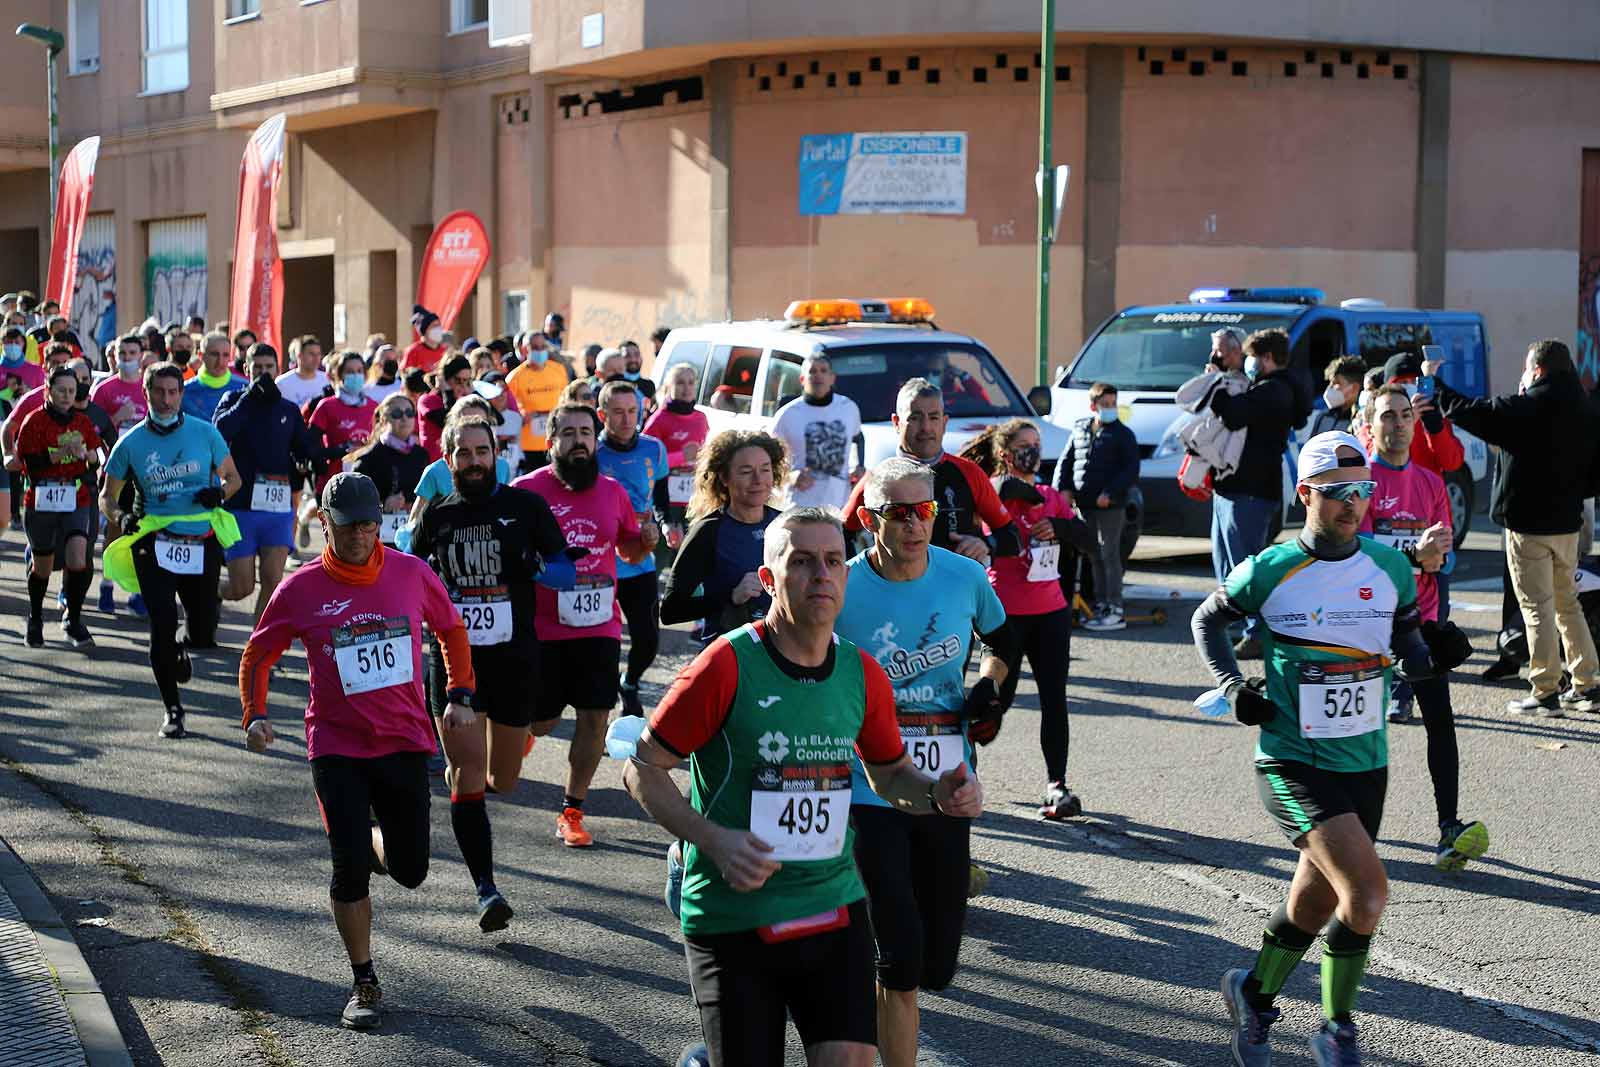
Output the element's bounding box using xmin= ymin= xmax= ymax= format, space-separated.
xmin=653 ymin=298 xmax=1067 ymax=480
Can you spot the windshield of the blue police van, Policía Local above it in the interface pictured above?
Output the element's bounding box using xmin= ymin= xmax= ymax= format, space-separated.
xmin=1058 ymin=307 xmax=1296 ymax=392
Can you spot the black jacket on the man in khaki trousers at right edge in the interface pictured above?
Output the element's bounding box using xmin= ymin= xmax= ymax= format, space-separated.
xmin=1435 ymin=371 xmax=1600 ymax=536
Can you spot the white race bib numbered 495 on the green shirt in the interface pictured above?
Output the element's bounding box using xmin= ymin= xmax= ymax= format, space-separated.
xmin=750 ymin=763 xmax=850 ymax=862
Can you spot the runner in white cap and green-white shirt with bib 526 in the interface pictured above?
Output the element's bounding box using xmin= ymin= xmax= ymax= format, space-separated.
xmin=1190 ymin=432 xmax=1470 ymax=1067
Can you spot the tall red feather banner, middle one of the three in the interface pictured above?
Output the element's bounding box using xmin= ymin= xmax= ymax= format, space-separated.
xmin=227 ymin=115 xmax=286 ymax=352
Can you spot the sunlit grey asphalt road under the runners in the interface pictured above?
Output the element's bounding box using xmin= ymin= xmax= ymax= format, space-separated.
xmin=0 ymin=531 xmax=1600 ymax=1067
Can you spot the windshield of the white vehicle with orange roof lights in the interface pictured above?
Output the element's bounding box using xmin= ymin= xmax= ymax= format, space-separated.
xmin=827 ymin=341 xmax=1030 ymax=422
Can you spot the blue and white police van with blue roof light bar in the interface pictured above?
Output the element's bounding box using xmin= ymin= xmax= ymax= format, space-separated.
xmin=1050 ymin=288 xmax=1488 ymax=547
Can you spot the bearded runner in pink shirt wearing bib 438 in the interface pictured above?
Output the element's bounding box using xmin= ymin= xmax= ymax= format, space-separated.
xmin=512 ymin=405 xmax=656 ymax=848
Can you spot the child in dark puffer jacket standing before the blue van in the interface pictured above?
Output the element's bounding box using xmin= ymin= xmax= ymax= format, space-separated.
xmin=1054 ymin=382 xmax=1139 ymax=630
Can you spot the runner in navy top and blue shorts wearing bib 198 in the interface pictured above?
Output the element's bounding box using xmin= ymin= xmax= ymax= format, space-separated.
xmin=214 ymin=342 xmax=326 ymax=619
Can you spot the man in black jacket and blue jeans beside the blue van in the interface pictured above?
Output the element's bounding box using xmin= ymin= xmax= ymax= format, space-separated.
xmin=1206 ymin=330 xmax=1310 ymax=659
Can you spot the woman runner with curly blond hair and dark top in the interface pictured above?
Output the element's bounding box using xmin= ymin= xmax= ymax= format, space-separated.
xmin=661 ymin=430 xmax=787 ymax=641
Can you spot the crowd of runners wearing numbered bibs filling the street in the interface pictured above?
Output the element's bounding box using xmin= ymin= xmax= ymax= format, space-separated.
xmin=0 ymin=286 xmax=1529 ymax=1067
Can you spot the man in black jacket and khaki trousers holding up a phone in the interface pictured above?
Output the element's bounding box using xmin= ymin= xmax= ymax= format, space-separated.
xmin=1421 ymin=341 xmax=1600 ymax=718
